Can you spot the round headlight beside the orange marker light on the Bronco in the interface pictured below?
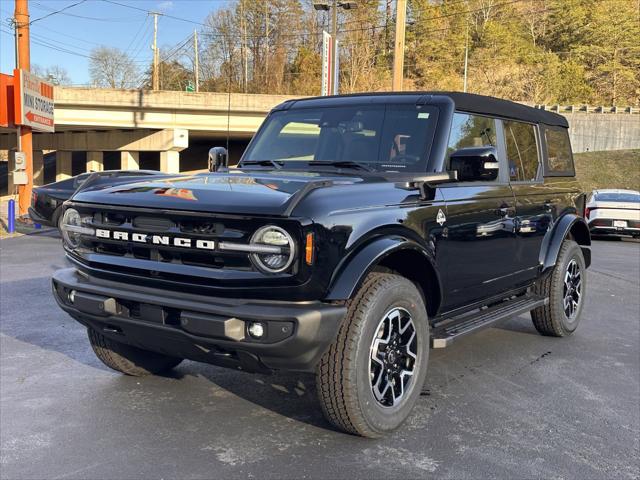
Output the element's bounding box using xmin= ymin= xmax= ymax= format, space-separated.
xmin=251 ymin=225 xmax=296 ymax=273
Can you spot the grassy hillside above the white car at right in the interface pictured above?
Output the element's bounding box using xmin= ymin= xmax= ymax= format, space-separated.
xmin=574 ymin=150 xmax=640 ymax=192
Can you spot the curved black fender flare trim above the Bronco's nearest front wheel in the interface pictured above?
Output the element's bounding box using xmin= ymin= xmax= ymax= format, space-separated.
xmin=325 ymin=235 xmax=441 ymax=301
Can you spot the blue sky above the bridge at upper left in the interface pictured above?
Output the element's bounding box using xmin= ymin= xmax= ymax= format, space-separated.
xmin=0 ymin=0 xmax=229 ymax=85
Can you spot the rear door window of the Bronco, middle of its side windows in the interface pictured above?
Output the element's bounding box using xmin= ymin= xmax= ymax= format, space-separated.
xmin=503 ymin=120 xmax=540 ymax=182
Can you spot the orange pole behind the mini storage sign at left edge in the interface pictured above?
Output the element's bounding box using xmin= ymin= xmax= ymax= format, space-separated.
xmin=9 ymin=0 xmax=33 ymax=215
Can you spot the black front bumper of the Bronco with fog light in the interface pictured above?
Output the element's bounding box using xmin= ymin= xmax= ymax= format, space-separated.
xmin=52 ymin=268 xmax=346 ymax=372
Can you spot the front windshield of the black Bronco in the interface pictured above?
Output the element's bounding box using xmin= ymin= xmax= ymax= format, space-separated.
xmin=242 ymin=105 xmax=438 ymax=172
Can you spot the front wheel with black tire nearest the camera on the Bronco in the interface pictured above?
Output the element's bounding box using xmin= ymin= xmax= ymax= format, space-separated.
xmin=316 ymin=273 xmax=429 ymax=438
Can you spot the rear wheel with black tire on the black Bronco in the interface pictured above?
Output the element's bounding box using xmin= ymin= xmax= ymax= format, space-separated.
xmin=531 ymin=240 xmax=587 ymax=337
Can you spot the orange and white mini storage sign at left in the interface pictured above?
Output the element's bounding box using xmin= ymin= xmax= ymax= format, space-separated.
xmin=14 ymin=69 xmax=55 ymax=132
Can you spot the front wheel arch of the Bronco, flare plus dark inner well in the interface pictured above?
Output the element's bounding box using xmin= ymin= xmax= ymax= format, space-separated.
xmin=326 ymin=235 xmax=442 ymax=317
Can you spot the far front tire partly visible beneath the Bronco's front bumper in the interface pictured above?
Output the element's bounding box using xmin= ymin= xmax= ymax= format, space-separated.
xmin=87 ymin=328 xmax=182 ymax=377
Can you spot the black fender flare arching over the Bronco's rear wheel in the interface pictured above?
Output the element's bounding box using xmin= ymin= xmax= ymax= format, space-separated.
xmin=540 ymin=213 xmax=591 ymax=271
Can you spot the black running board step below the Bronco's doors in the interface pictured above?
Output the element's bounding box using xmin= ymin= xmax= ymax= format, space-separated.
xmin=431 ymin=295 xmax=549 ymax=348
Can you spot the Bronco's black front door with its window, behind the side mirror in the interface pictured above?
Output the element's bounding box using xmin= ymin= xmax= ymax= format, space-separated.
xmin=437 ymin=113 xmax=516 ymax=312
